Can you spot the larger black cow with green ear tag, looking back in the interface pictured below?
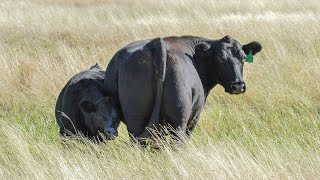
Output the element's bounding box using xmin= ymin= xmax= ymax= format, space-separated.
xmin=105 ymin=36 xmax=262 ymax=138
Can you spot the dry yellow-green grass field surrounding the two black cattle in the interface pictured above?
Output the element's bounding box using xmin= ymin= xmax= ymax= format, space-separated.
xmin=0 ymin=0 xmax=320 ymax=179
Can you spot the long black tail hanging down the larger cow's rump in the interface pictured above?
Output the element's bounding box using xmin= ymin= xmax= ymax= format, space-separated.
xmin=138 ymin=38 xmax=167 ymax=139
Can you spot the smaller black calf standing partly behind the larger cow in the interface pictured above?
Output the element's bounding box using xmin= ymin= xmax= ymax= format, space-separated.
xmin=55 ymin=64 xmax=118 ymax=141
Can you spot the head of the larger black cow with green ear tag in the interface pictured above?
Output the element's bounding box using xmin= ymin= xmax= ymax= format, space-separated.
xmin=196 ymin=36 xmax=262 ymax=94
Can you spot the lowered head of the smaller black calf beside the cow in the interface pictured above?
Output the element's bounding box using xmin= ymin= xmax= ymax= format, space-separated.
xmin=79 ymin=91 xmax=119 ymax=140
